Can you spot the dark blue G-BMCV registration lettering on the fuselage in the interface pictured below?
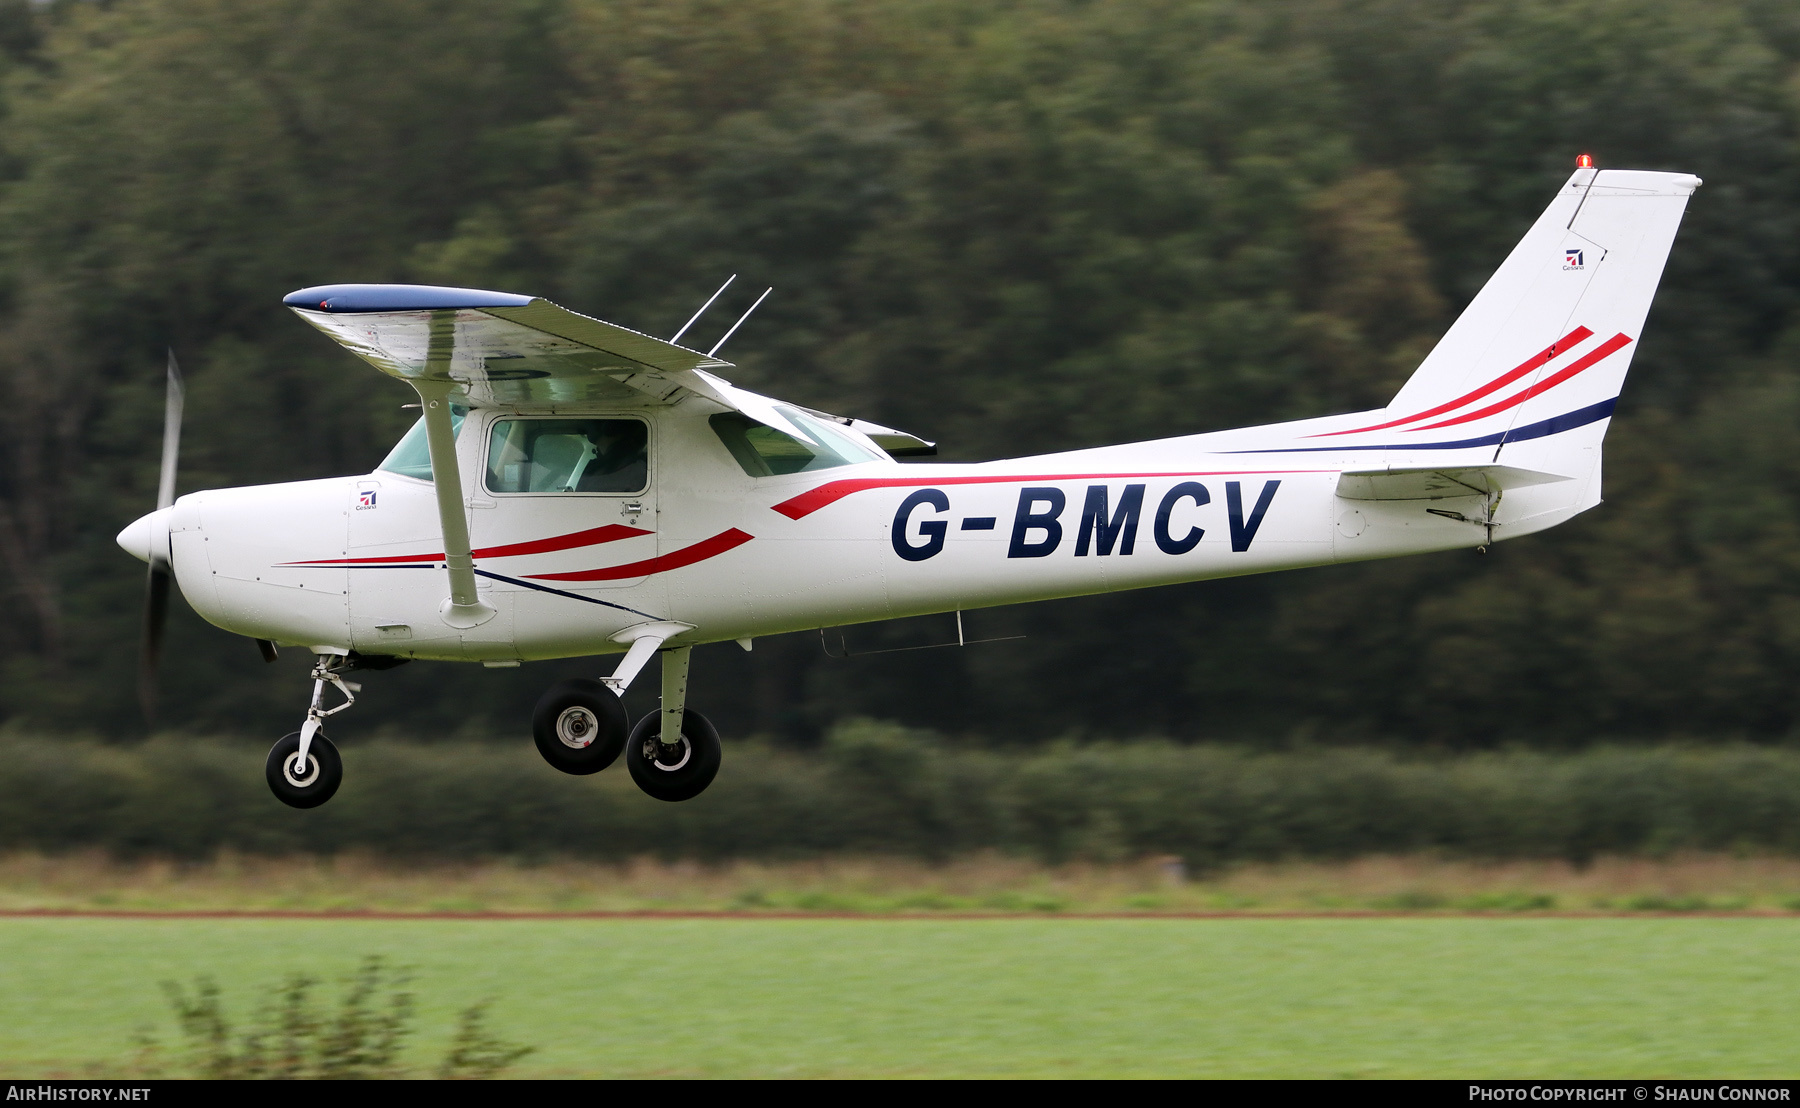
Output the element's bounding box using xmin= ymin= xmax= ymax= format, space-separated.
xmin=893 ymin=480 xmax=1282 ymax=561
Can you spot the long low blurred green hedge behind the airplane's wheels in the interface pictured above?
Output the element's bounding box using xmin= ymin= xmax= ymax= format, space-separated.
xmin=10 ymin=723 xmax=1800 ymax=867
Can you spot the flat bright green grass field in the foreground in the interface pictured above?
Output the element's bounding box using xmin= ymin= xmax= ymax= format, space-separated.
xmin=0 ymin=917 xmax=1800 ymax=1077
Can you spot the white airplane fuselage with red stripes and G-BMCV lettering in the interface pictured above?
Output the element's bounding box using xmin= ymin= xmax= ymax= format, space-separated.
xmin=140 ymin=398 xmax=1533 ymax=664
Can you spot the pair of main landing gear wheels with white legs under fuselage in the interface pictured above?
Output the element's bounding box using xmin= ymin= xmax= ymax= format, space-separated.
xmin=531 ymin=624 xmax=724 ymax=800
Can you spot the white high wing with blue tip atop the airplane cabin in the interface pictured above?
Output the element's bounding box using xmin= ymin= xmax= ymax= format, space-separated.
xmin=283 ymin=284 xmax=931 ymax=453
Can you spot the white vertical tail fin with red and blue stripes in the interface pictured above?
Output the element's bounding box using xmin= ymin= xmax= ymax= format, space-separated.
xmin=1307 ymin=167 xmax=1701 ymax=534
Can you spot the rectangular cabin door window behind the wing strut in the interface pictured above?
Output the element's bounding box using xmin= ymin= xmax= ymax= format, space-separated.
xmin=488 ymin=419 xmax=650 ymax=493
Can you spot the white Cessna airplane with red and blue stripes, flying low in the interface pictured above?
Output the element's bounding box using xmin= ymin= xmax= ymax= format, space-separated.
xmin=119 ymin=155 xmax=1701 ymax=808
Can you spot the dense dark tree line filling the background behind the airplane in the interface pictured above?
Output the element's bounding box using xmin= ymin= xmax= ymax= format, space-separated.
xmin=0 ymin=0 xmax=1800 ymax=745
